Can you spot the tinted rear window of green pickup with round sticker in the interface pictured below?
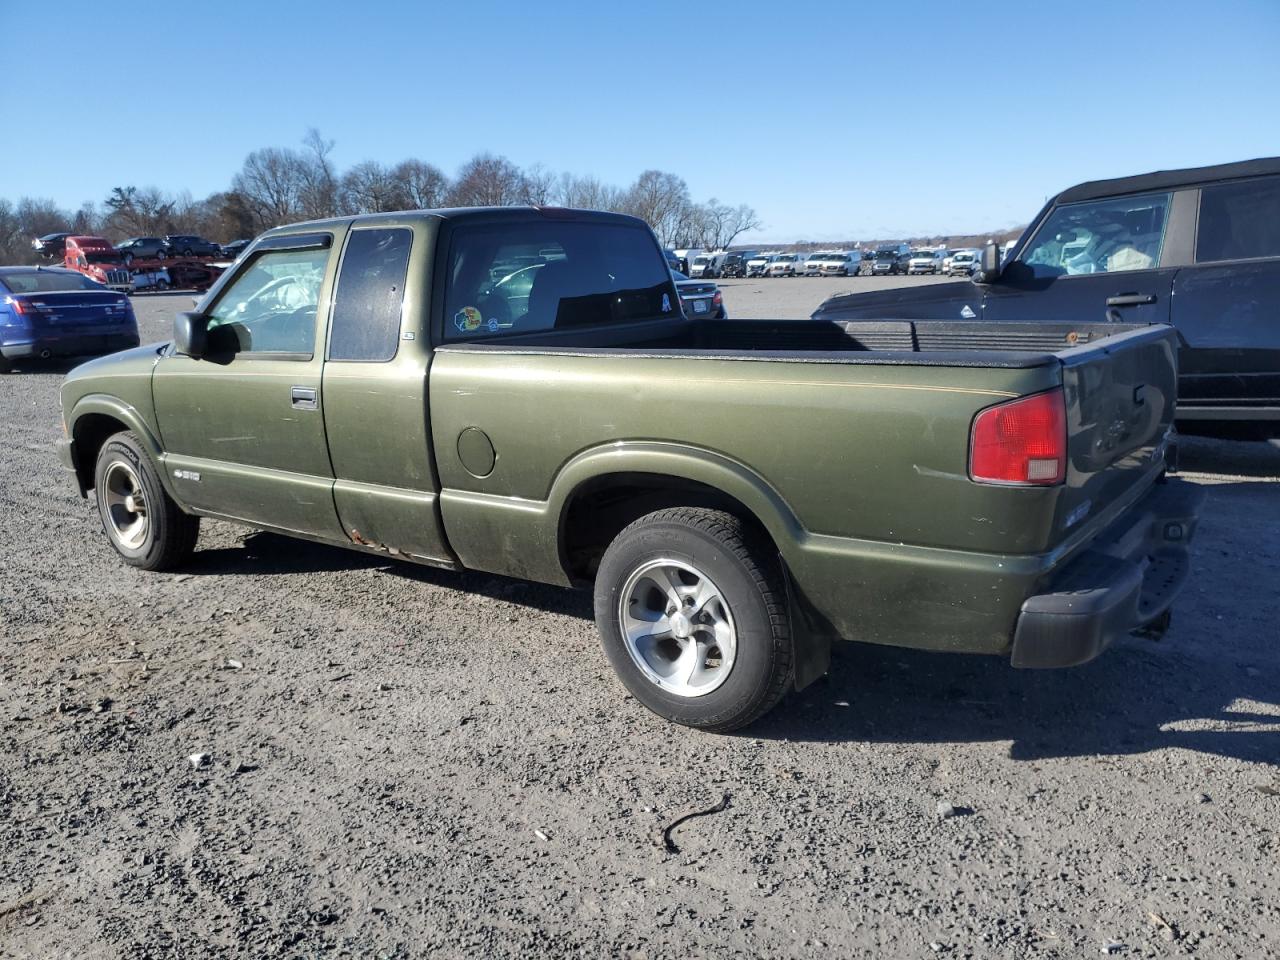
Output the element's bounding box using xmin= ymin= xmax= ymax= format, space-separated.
xmin=444 ymin=220 xmax=680 ymax=339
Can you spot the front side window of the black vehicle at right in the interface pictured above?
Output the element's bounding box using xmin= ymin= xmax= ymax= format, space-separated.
xmin=1020 ymin=193 xmax=1169 ymax=278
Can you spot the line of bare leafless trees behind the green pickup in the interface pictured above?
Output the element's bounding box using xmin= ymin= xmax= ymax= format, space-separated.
xmin=0 ymin=129 xmax=760 ymax=264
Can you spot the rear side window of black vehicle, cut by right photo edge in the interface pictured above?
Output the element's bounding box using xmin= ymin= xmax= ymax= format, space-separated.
xmin=1196 ymin=177 xmax=1280 ymax=264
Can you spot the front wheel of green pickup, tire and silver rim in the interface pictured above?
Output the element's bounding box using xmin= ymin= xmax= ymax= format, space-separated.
xmin=93 ymin=431 xmax=200 ymax=571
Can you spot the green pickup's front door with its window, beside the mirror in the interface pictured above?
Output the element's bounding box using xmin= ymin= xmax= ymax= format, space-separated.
xmin=152 ymin=233 xmax=342 ymax=539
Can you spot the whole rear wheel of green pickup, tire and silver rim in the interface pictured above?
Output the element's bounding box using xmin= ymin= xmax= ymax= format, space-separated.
xmin=595 ymin=507 xmax=791 ymax=732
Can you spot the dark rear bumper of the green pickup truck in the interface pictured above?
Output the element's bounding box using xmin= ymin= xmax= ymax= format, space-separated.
xmin=1011 ymin=480 xmax=1204 ymax=668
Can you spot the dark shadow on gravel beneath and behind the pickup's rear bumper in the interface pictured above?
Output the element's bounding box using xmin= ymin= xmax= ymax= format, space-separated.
xmin=744 ymin=626 xmax=1280 ymax=763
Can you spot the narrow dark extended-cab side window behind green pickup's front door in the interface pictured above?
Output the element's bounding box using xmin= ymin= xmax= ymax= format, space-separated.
xmin=329 ymin=228 xmax=413 ymax=362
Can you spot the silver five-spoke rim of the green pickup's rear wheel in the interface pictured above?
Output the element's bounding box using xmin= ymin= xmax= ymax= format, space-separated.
xmin=618 ymin=559 xmax=737 ymax=698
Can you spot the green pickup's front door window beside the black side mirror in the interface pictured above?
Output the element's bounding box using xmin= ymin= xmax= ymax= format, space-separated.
xmin=209 ymin=248 xmax=329 ymax=357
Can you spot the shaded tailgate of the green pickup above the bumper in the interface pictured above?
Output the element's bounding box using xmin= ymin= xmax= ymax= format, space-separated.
xmin=1053 ymin=324 xmax=1178 ymax=543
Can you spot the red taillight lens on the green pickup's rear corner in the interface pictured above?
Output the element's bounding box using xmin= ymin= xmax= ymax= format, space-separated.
xmin=969 ymin=390 xmax=1066 ymax=486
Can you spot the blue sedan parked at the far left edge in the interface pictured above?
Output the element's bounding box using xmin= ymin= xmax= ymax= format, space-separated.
xmin=0 ymin=266 xmax=138 ymax=372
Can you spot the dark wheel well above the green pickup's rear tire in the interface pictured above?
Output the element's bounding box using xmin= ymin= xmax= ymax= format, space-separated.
xmin=561 ymin=474 xmax=776 ymax=584
